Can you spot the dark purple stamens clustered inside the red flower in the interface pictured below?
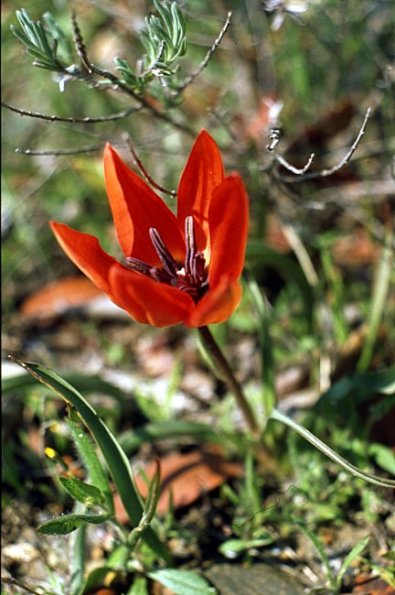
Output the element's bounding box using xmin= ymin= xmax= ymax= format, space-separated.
xmin=126 ymin=215 xmax=208 ymax=302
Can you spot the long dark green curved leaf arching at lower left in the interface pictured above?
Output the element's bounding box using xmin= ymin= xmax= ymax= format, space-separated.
xmin=15 ymin=359 xmax=171 ymax=563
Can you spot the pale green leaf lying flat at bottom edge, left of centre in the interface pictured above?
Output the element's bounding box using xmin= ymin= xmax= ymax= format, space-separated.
xmin=148 ymin=568 xmax=216 ymax=595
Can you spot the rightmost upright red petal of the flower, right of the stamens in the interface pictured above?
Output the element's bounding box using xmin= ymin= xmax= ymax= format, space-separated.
xmin=208 ymin=173 xmax=248 ymax=287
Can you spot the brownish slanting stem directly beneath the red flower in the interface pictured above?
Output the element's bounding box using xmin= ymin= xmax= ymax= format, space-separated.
xmin=198 ymin=326 xmax=261 ymax=435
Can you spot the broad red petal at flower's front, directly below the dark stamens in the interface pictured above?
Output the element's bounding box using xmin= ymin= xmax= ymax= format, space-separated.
xmin=110 ymin=267 xmax=194 ymax=327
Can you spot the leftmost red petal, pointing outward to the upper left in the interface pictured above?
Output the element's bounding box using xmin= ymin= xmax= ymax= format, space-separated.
xmin=50 ymin=221 xmax=118 ymax=294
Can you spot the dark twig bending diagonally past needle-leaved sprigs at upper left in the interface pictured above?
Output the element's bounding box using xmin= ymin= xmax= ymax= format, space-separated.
xmin=71 ymin=12 xmax=195 ymax=137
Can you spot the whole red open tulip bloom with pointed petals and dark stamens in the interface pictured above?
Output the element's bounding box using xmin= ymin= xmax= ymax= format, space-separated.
xmin=51 ymin=130 xmax=248 ymax=327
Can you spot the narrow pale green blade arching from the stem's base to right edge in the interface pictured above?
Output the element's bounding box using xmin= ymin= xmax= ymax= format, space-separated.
xmin=271 ymin=409 xmax=395 ymax=488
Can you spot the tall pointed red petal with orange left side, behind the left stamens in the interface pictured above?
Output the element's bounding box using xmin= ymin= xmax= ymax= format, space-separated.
xmin=104 ymin=144 xmax=185 ymax=266
